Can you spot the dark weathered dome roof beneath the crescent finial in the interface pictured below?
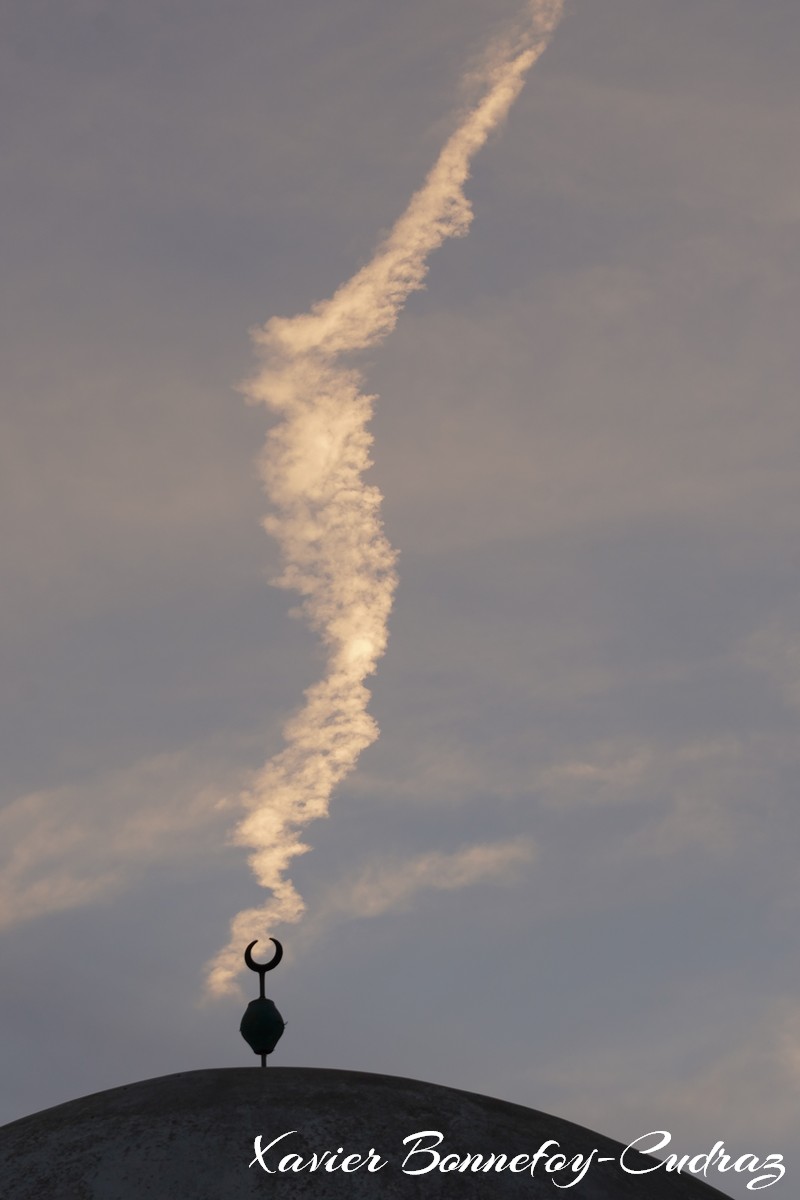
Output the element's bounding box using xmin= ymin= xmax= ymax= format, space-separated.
xmin=0 ymin=1067 xmax=722 ymax=1200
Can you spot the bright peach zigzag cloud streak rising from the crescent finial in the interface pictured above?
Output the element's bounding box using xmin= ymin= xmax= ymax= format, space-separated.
xmin=207 ymin=0 xmax=564 ymax=992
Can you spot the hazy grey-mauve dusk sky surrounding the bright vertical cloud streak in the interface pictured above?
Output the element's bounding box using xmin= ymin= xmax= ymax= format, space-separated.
xmin=0 ymin=0 xmax=800 ymax=1196
